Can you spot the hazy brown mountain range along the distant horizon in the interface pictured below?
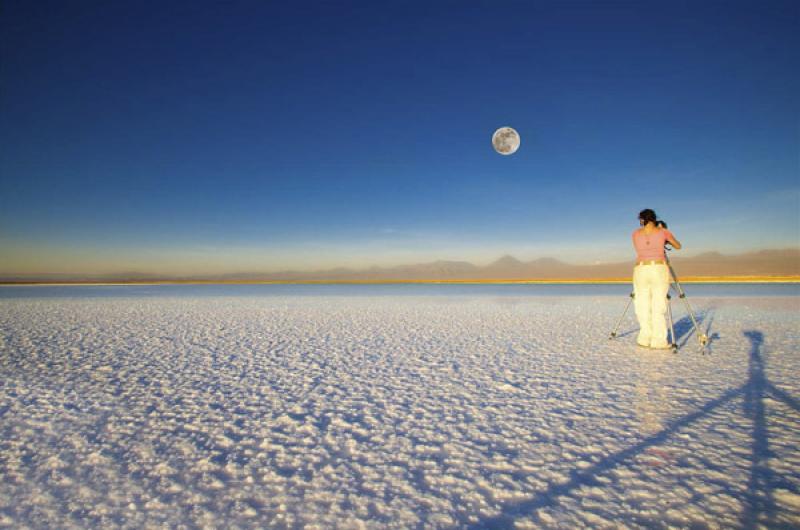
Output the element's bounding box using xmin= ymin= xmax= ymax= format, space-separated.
xmin=0 ymin=248 xmax=800 ymax=283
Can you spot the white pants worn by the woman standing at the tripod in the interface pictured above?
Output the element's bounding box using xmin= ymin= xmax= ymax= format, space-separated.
xmin=633 ymin=263 xmax=669 ymax=348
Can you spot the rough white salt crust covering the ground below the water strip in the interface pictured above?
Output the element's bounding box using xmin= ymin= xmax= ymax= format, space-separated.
xmin=0 ymin=296 xmax=800 ymax=528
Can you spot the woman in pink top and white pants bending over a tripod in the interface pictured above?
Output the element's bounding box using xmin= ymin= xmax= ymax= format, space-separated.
xmin=633 ymin=208 xmax=681 ymax=349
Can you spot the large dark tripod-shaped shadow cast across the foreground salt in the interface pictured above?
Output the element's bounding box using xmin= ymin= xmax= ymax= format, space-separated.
xmin=469 ymin=328 xmax=798 ymax=528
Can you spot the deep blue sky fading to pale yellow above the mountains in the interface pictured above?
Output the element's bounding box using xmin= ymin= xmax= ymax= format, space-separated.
xmin=0 ymin=0 xmax=800 ymax=274
